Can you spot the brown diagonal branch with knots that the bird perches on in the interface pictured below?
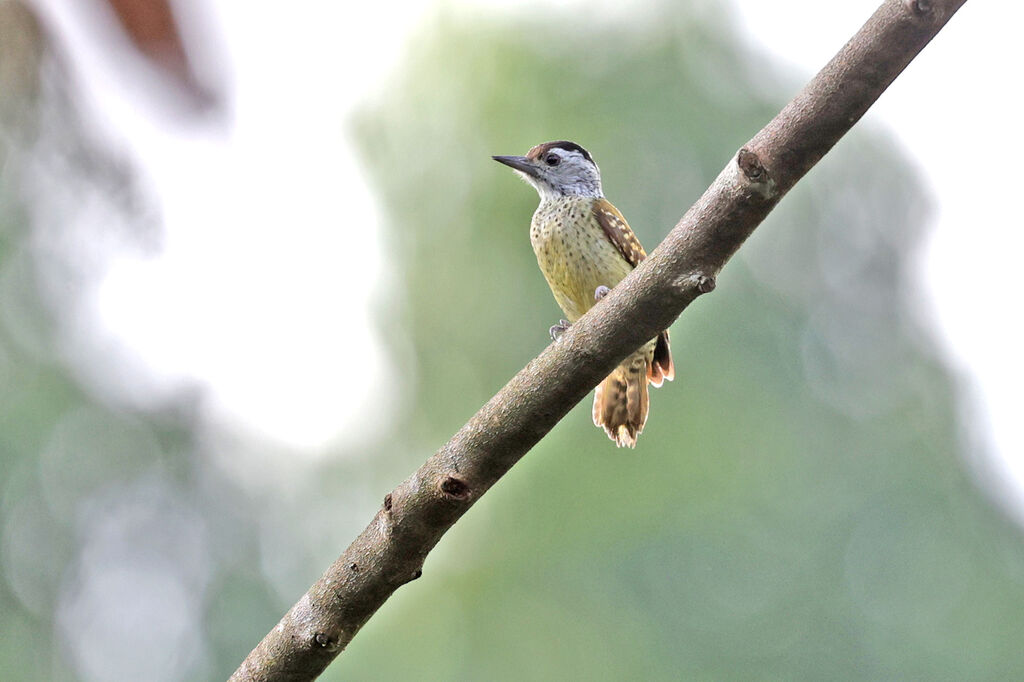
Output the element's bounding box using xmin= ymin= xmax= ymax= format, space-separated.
xmin=231 ymin=0 xmax=966 ymax=681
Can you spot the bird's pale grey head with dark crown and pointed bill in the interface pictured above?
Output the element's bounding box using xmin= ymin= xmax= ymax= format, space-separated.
xmin=492 ymin=139 xmax=603 ymax=200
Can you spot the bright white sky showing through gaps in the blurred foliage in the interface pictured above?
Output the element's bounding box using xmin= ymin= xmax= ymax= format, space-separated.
xmin=29 ymin=0 xmax=1024 ymax=509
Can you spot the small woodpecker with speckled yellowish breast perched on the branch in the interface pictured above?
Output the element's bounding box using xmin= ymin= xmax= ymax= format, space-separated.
xmin=492 ymin=139 xmax=676 ymax=447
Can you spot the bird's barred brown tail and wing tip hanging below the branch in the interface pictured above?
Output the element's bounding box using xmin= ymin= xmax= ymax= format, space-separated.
xmin=594 ymin=332 xmax=676 ymax=447
